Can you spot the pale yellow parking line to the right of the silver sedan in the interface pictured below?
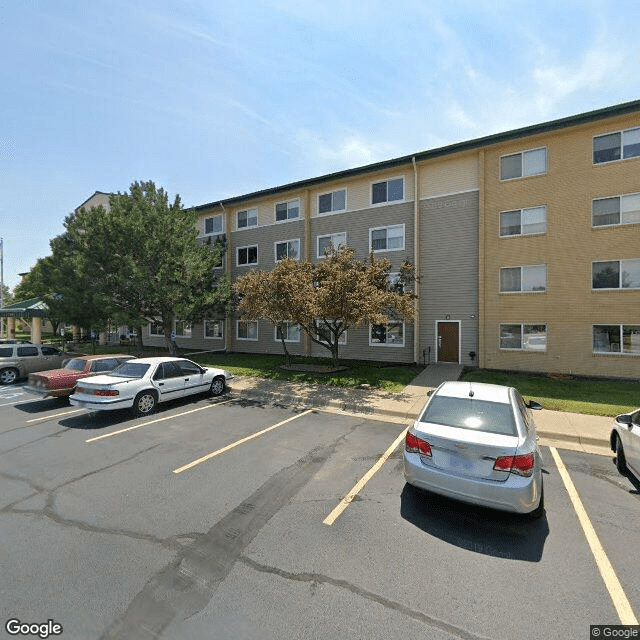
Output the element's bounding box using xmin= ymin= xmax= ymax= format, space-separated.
xmin=549 ymin=447 xmax=638 ymax=625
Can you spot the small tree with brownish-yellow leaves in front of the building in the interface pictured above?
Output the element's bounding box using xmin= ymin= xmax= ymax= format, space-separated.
xmin=234 ymin=247 xmax=416 ymax=366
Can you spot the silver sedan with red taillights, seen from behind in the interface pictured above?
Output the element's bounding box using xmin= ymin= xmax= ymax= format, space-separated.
xmin=404 ymin=382 xmax=544 ymax=517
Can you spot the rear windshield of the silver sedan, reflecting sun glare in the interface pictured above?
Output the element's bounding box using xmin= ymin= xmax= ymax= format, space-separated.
xmin=420 ymin=396 xmax=518 ymax=436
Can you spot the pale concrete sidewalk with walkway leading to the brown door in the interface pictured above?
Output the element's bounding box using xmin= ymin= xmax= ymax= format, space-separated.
xmin=230 ymin=363 xmax=613 ymax=456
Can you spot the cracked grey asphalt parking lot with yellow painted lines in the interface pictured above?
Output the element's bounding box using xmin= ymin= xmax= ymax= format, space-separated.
xmin=0 ymin=385 xmax=640 ymax=640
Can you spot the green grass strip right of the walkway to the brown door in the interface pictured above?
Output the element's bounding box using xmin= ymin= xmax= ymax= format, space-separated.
xmin=462 ymin=371 xmax=640 ymax=416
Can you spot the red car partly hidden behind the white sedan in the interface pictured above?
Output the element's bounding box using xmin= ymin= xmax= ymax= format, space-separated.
xmin=26 ymin=353 xmax=135 ymax=398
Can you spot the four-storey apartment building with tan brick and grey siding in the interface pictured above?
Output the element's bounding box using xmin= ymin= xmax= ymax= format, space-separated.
xmin=141 ymin=101 xmax=640 ymax=378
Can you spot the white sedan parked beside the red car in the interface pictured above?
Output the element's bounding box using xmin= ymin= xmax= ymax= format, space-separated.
xmin=69 ymin=357 xmax=233 ymax=416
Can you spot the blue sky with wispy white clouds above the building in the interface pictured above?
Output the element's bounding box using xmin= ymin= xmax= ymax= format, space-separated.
xmin=0 ymin=0 xmax=640 ymax=287
